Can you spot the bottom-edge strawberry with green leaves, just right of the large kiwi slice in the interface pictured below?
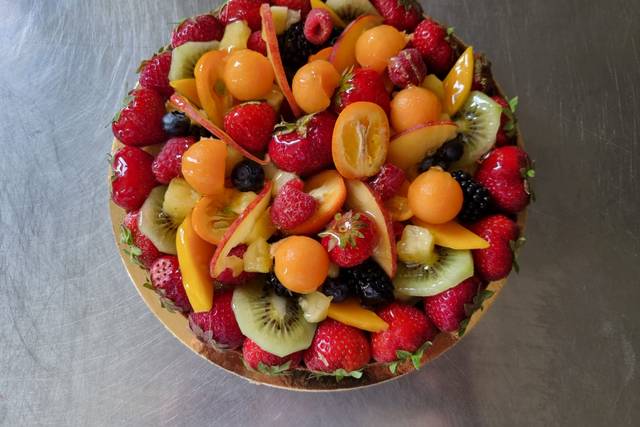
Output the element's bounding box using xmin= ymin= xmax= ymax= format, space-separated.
xmin=304 ymin=319 xmax=371 ymax=378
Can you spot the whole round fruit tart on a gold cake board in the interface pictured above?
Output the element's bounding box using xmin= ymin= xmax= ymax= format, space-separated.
xmin=110 ymin=0 xmax=534 ymax=390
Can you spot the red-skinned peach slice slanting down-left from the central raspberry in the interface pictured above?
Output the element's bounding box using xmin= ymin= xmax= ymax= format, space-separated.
xmin=210 ymin=182 xmax=272 ymax=277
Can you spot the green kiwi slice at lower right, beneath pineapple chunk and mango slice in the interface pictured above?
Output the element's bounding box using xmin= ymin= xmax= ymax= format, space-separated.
xmin=393 ymin=247 xmax=473 ymax=298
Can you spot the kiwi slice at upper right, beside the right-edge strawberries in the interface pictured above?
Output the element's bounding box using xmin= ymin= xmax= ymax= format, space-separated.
xmin=453 ymin=91 xmax=502 ymax=169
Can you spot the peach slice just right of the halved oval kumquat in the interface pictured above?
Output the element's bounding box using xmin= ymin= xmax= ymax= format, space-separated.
xmin=388 ymin=121 xmax=458 ymax=171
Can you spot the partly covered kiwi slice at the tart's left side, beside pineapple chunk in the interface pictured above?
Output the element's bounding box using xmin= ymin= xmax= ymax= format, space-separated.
xmin=138 ymin=185 xmax=180 ymax=255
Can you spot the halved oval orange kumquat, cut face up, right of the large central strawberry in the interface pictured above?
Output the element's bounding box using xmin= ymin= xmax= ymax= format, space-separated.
xmin=332 ymin=102 xmax=390 ymax=179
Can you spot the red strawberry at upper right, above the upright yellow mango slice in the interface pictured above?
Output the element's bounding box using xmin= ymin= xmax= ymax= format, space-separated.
xmin=412 ymin=18 xmax=455 ymax=77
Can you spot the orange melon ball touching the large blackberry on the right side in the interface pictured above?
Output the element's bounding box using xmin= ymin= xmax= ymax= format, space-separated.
xmin=408 ymin=168 xmax=463 ymax=224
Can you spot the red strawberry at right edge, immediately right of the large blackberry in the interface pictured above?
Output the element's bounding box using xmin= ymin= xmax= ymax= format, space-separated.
xmin=475 ymin=145 xmax=535 ymax=214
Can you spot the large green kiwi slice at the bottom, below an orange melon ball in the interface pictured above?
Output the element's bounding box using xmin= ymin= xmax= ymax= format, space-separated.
xmin=232 ymin=279 xmax=316 ymax=357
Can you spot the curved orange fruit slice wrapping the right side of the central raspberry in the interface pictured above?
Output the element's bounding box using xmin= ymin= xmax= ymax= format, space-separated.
xmin=288 ymin=170 xmax=347 ymax=234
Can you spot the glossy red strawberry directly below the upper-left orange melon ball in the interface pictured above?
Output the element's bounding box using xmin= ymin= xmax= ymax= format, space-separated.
xmin=224 ymin=102 xmax=276 ymax=154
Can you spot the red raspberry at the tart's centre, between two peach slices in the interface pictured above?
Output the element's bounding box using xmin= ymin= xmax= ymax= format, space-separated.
xmin=270 ymin=179 xmax=318 ymax=230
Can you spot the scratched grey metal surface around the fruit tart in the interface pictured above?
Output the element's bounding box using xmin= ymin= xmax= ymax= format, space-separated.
xmin=0 ymin=0 xmax=640 ymax=426
